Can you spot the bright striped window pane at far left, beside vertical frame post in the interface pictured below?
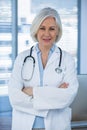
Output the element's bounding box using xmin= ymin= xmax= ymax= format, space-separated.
xmin=0 ymin=0 xmax=12 ymax=94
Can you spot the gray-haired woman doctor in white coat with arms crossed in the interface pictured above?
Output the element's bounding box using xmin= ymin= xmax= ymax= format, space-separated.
xmin=9 ymin=7 xmax=78 ymax=130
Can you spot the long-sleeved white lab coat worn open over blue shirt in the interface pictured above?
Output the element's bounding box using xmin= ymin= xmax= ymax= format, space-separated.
xmin=8 ymin=47 xmax=78 ymax=130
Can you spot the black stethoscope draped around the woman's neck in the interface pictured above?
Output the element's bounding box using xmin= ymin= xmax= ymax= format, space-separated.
xmin=21 ymin=46 xmax=62 ymax=81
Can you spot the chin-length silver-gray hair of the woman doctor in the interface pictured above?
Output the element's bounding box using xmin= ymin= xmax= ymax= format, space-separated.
xmin=30 ymin=7 xmax=62 ymax=42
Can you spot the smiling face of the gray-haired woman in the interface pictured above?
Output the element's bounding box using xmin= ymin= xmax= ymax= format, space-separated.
xmin=37 ymin=17 xmax=58 ymax=47
